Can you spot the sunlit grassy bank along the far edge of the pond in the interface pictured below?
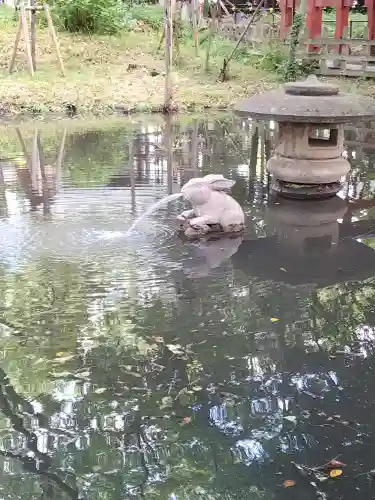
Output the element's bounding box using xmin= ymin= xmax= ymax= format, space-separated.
xmin=0 ymin=7 xmax=275 ymax=117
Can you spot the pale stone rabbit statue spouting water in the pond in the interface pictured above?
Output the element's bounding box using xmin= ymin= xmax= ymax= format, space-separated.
xmin=177 ymin=174 xmax=245 ymax=237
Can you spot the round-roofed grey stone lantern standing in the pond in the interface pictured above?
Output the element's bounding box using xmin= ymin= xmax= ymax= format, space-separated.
xmin=234 ymin=75 xmax=375 ymax=198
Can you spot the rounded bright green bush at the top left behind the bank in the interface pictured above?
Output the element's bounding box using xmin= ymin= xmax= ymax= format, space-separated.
xmin=53 ymin=0 xmax=131 ymax=35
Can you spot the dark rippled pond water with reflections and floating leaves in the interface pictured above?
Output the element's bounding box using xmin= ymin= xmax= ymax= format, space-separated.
xmin=0 ymin=115 xmax=375 ymax=500
